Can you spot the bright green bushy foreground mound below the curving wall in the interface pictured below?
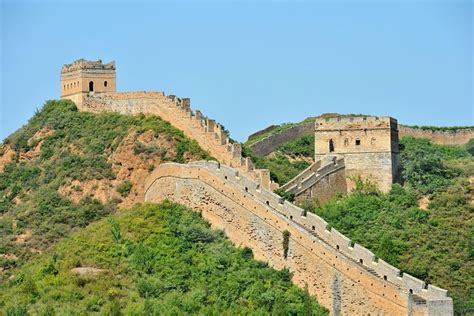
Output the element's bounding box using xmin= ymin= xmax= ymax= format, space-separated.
xmin=0 ymin=202 xmax=327 ymax=315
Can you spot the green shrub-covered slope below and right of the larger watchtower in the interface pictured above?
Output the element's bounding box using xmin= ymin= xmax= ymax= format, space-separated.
xmin=302 ymin=138 xmax=474 ymax=315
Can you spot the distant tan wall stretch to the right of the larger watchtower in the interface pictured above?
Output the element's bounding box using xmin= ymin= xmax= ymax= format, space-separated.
xmin=398 ymin=126 xmax=474 ymax=145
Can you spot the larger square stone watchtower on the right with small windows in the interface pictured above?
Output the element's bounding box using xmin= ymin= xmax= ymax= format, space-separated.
xmin=315 ymin=116 xmax=400 ymax=192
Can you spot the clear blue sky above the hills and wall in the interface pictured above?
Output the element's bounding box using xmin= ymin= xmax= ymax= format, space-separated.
xmin=0 ymin=0 xmax=474 ymax=141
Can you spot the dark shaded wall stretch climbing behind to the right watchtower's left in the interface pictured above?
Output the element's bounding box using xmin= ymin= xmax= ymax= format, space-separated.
xmin=250 ymin=122 xmax=314 ymax=156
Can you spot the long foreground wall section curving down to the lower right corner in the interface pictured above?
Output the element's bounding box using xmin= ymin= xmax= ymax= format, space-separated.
xmin=145 ymin=161 xmax=453 ymax=315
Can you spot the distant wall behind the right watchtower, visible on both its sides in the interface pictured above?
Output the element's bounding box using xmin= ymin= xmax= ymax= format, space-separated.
xmin=249 ymin=122 xmax=474 ymax=157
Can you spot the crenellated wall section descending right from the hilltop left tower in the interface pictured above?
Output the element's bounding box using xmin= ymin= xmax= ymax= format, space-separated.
xmin=80 ymin=91 xmax=278 ymax=190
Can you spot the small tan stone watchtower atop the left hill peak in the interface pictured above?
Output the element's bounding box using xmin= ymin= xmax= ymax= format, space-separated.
xmin=61 ymin=59 xmax=116 ymax=108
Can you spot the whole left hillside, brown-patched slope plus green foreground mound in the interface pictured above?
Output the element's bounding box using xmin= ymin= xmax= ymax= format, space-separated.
xmin=0 ymin=100 xmax=326 ymax=315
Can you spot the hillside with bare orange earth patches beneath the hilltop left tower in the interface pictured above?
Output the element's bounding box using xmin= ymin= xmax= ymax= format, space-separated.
xmin=0 ymin=100 xmax=209 ymax=281
